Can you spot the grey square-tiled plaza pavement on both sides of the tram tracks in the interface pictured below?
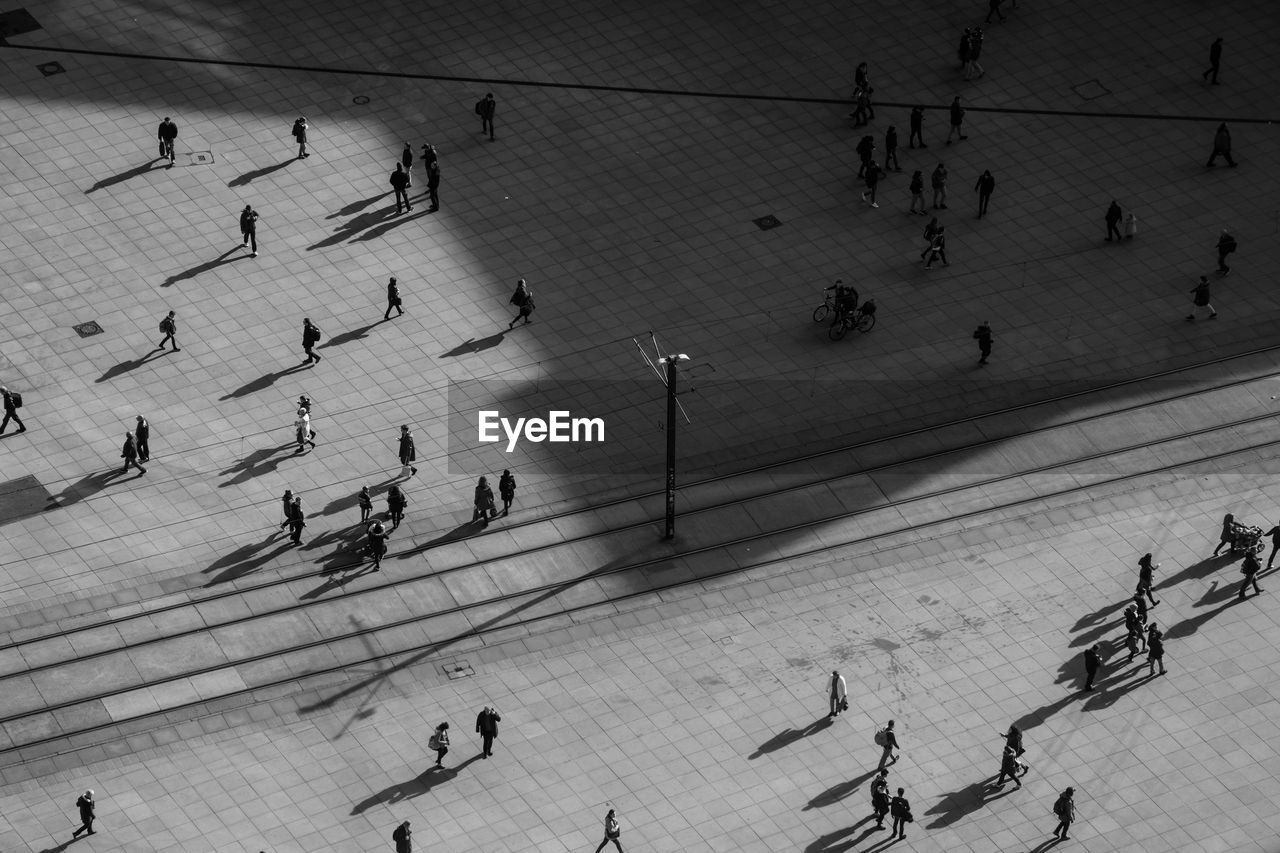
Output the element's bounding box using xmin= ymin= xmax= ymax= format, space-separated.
xmin=0 ymin=0 xmax=1280 ymax=853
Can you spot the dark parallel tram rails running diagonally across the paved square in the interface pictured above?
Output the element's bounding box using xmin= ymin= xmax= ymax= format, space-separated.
xmin=0 ymin=378 xmax=1280 ymax=754
